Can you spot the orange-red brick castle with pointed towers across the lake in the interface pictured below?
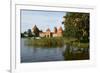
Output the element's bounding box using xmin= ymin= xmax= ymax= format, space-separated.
xmin=32 ymin=25 xmax=63 ymax=38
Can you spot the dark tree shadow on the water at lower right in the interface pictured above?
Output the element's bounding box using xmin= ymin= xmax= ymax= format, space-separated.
xmin=63 ymin=45 xmax=89 ymax=60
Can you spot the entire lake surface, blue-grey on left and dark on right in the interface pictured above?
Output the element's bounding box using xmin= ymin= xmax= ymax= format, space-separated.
xmin=21 ymin=38 xmax=89 ymax=63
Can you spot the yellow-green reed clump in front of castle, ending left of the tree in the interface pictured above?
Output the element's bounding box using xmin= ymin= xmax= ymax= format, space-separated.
xmin=26 ymin=38 xmax=64 ymax=47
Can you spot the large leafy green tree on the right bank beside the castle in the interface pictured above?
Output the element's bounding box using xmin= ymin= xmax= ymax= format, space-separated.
xmin=62 ymin=12 xmax=89 ymax=40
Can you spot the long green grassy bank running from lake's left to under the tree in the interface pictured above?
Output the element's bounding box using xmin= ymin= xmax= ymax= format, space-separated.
xmin=22 ymin=37 xmax=89 ymax=48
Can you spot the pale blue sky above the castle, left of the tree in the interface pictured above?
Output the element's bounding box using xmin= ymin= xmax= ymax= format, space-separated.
xmin=21 ymin=10 xmax=65 ymax=32
